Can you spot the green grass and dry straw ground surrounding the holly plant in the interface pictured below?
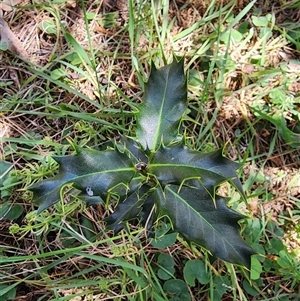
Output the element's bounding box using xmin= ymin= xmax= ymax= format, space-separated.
xmin=0 ymin=0 xmax=300 ymax=301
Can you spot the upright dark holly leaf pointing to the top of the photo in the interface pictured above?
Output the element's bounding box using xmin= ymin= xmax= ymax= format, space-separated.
xmin=136 ymin=59 xmax=187 ymax=151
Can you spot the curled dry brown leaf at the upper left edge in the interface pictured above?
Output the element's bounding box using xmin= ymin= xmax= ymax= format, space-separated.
xmin=0 ymin=17 xmax=29 ymax=59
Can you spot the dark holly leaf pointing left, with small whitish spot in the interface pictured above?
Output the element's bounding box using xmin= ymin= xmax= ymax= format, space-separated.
xmin=30 ymin=149 xmax=135 ymax=212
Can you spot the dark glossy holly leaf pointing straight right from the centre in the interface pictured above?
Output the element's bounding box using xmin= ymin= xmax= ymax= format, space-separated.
xmin=148 ymin=145 xmax=243 ymax=195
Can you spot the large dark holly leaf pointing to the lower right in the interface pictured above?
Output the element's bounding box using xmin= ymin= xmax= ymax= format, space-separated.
xmin=156 ymin=185 xmax=254 ymax=267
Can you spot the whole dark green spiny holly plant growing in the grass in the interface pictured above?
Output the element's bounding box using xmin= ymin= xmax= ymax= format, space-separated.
xmin=30 ymin=59 xmax=253 ymax=268
